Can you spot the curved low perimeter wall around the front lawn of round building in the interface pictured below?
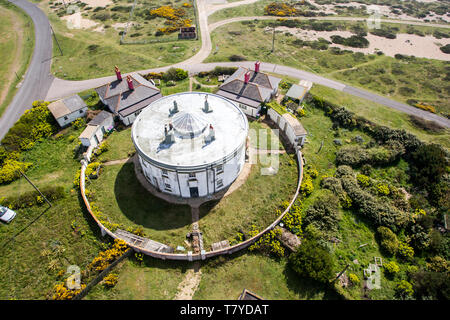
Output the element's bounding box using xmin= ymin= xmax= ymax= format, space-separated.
xmin=80 ymin=114 xmax=303 ymax=261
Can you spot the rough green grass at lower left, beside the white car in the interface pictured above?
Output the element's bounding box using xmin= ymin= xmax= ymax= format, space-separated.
xmin=0 ymin=128 xmax=108 ymax=299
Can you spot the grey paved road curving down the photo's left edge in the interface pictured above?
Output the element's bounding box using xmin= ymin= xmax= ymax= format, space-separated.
xmin=0 ymin=0 xmax=53 ymax=140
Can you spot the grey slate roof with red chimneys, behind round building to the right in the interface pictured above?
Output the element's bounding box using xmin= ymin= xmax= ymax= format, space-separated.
xmin=218 ymin=67 xmax=281 ymax=106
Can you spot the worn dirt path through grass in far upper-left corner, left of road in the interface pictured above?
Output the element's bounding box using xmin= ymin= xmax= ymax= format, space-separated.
xmin=0 ymin=6 xmax=23 ymax=105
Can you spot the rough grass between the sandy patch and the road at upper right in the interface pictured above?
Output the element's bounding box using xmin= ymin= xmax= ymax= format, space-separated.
xmin=205 ymin=21 xmax=450 ymax=115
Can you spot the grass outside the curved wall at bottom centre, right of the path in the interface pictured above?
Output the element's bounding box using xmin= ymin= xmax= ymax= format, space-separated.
xmin=194 ymin=251 xmax=338 ymax=300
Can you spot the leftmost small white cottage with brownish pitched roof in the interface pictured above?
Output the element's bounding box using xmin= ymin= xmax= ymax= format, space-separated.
xmin=48 ymin=94 xmax=88 ymax=128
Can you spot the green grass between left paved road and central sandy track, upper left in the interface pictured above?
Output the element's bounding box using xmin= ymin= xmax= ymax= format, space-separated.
xmin=46 ymin=2 xmax=201 ymax=80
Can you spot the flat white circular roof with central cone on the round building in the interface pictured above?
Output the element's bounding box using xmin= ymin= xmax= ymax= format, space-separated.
xmin=131 ymin=92 xmax=248 ymax=169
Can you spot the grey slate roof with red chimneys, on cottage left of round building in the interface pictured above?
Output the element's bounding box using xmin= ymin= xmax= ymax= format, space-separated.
xmin=95 ymin=73 xmax=162 ymax=117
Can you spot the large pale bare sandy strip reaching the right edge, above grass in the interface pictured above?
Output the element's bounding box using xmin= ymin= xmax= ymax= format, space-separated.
xmin=277 ymin=27 xmax=450 ymax=61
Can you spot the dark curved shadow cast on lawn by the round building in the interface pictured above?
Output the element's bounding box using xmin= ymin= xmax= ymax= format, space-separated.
xmin=114 ymin=162 xmax=191 ymax=230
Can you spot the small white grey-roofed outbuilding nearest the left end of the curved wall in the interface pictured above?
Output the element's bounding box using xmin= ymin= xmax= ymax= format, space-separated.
xmin=78 ymin=110 xmax=114 ymax=147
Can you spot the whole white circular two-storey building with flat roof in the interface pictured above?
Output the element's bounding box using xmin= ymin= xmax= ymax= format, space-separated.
xmin=131 ymin=92 xmax=248 ymax=198
